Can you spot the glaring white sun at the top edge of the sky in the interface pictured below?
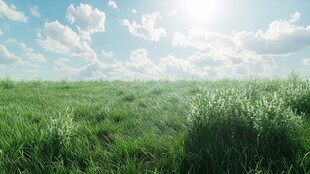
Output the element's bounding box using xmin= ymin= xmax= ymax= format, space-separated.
xmin=182 ymin=0 xmax=220 ymax=24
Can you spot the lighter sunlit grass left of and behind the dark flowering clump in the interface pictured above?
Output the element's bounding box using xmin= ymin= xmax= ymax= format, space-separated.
xmin=0 ymin=80 xmax=310 ymax=173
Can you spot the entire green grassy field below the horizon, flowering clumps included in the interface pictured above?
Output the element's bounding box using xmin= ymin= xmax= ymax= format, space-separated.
xmin=0 ymin=74 xmax=310 ymax=174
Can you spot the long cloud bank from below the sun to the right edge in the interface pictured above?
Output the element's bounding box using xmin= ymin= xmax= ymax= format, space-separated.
xmin=172 ymin=13 xmax=310 ymax=55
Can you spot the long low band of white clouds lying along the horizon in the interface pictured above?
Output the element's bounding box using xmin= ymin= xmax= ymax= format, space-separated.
xmin=55 ymin=49 xmax=273 ymax=80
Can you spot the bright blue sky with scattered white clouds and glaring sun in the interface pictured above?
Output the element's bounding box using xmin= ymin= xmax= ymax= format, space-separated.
xmin=0 ymin=0 xmax=310 ymax=80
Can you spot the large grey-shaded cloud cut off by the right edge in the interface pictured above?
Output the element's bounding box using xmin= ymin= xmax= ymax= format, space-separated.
xmin=235 ymin=13 xmax=310 ymax=55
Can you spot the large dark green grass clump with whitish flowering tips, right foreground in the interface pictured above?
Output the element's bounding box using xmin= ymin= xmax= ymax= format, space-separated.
xmin=182 ymin=89 xmax=305 ymax=173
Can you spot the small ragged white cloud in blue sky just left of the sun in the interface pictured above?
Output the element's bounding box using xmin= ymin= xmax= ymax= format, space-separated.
xmin=121 ymin=12 xmax=166 ymax=42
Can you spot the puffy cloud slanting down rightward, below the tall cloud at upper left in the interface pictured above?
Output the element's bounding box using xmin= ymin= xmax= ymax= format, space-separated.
xmin=37 ymin=21 xmax=97 ymax=60
